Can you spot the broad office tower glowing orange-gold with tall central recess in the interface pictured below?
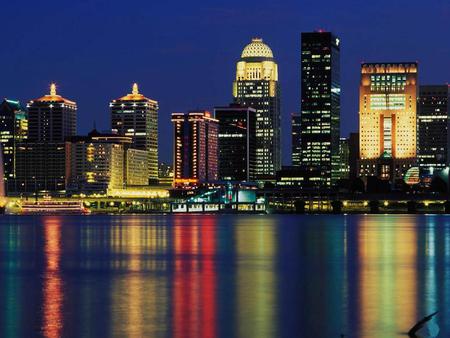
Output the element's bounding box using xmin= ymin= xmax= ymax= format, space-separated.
xmin=359 ymin=62 xmax=418 ymax=182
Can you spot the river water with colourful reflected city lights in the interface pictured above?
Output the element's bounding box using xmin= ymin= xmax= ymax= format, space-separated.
xmin=0 ymin=215 xmax=450 ymax=338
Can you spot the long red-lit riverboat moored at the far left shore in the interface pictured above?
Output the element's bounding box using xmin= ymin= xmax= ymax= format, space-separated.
xmin=19 ymin=200 xmax=90 ymax=215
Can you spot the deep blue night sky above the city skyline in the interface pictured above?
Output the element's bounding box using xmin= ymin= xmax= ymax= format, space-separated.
xmin=0 ymin=0 xmax=450 ymax=164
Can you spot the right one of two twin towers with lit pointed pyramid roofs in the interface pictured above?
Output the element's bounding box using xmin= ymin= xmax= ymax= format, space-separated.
xmin=110 ymin=83 xmax=159 ymax=182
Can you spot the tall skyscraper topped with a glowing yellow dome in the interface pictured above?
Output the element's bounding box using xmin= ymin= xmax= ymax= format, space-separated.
xmin=233 ymin=38 xmax=281 ymax=180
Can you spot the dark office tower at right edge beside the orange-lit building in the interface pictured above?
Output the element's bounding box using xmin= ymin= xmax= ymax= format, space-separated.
xmin=417 ymin=85 xmax=450 ymax=174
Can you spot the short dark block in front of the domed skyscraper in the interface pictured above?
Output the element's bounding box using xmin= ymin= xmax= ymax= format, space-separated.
xmin=214 ymin=104 xmax=256 ymax=181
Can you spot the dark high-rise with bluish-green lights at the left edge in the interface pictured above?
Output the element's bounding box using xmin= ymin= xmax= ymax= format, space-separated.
xmin=0 ymin=99 xmax=28 ymax=187
